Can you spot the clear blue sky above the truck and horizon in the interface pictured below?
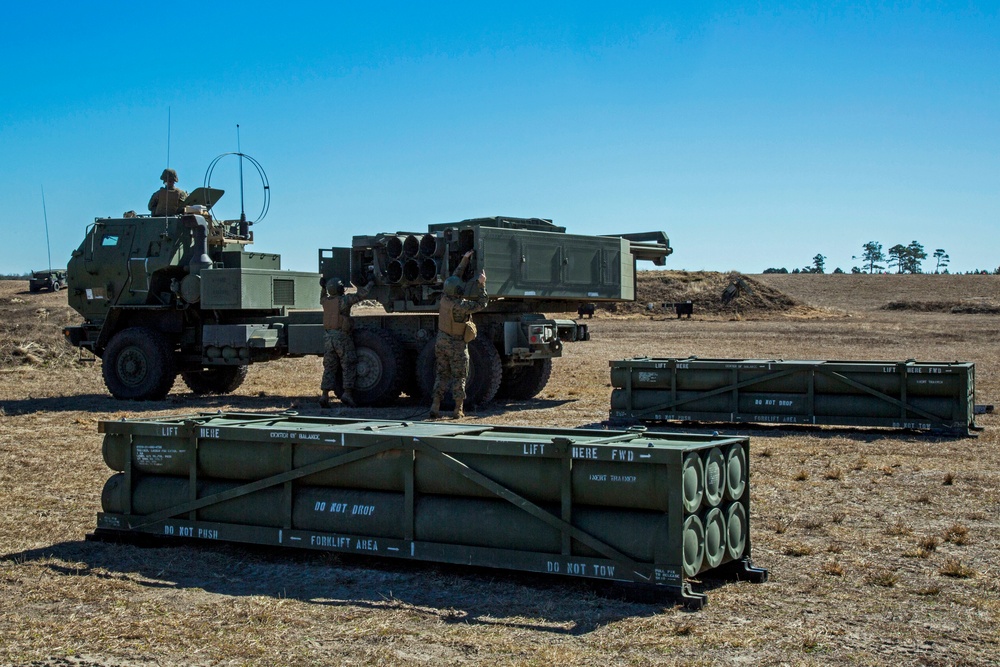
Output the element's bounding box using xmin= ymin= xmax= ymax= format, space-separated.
xmin=0 ymin=0 xmax=1000 ymax=273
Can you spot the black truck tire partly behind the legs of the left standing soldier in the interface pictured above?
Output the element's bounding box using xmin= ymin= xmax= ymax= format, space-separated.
xmin=333 ymin=328 xmax=407 ymax=406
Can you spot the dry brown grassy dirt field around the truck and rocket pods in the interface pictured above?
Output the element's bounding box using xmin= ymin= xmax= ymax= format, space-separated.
xmin=0 ymin=275 xmax=1000 ymax=666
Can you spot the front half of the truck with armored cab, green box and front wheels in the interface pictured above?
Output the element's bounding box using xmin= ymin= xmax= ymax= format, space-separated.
xmin=64 ymin=188 xmax=319 ymax=400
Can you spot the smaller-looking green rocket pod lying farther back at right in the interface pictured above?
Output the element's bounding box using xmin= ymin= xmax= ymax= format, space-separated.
xmin=610 ymin=357 xmax=975 ymax=433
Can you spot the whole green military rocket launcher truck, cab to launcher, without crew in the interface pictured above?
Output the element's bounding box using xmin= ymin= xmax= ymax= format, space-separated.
xmin=64 ymin=188 xmax=672 ymax=405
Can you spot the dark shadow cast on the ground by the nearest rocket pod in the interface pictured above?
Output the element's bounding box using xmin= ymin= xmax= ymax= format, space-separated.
xmin=0 ymin=541 xmax=677 ymax=635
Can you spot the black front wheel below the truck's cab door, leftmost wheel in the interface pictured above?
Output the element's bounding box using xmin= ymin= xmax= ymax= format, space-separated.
xmin=101 ymin=327 xmax=177 ymax=401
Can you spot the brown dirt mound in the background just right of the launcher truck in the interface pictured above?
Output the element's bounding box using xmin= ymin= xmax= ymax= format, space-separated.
xmin=613 ymin=271 xmax=821 ymax=317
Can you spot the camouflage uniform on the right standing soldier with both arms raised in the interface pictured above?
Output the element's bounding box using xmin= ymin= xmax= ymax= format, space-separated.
xmin=431 ymin=260 xmax=489 ymax=412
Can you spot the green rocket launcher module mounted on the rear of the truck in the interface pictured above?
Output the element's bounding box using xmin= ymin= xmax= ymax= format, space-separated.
xmin=328 ymin=218 xmax=656 ymax=312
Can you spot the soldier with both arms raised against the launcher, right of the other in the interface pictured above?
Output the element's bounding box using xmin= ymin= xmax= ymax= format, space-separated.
xmin=430 ymin=250 xmax=489 ymax=419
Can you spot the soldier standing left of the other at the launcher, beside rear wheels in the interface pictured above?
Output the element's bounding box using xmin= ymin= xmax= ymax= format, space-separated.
xmin=319 ymin=278 xmax=374 ymax=408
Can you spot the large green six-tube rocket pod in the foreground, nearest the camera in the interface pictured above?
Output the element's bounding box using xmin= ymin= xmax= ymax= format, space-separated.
xmin=96 ymin=414 xmax=766 ymax=606
